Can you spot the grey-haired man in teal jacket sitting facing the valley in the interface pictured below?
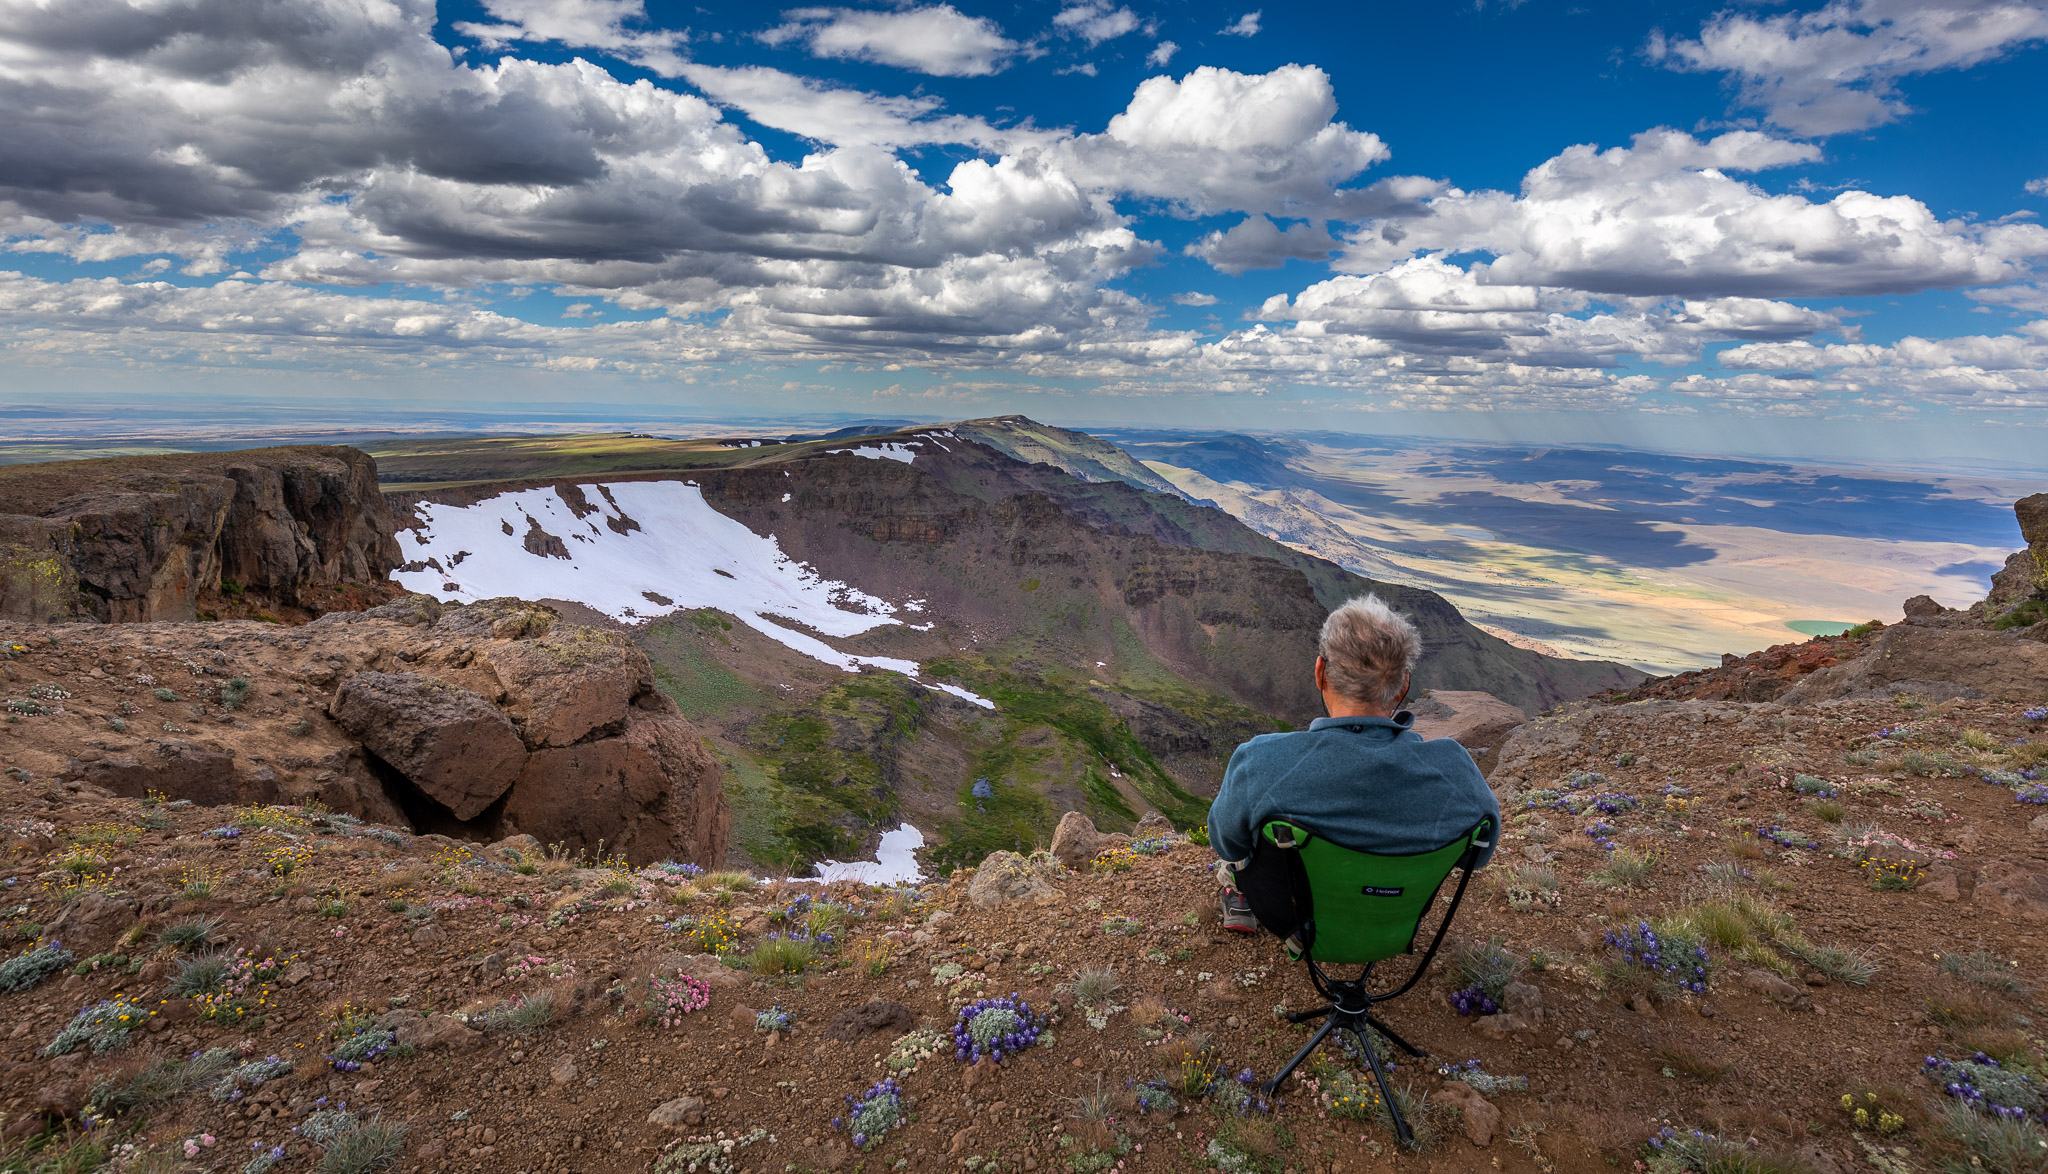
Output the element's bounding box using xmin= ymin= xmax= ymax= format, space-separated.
xmin=1208 ymin=594 xmax=1501 ymax=934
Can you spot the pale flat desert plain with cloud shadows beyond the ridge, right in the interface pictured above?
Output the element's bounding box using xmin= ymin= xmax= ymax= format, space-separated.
xmin=1106 ymin=432 xmax=2048 ymax=672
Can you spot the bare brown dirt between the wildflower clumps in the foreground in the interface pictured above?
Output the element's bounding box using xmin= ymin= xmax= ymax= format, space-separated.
xmin=0 ymin=676 xmax=2048 ymax=1174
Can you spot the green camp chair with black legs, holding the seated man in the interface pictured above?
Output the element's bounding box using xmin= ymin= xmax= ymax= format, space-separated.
xmin=1237 ymin=817 xmax=1493 ymax=1143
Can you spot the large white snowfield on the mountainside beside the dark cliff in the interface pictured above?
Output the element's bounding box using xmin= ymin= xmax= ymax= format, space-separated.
xmin=391 ymin=481 xmax=993 ymax=709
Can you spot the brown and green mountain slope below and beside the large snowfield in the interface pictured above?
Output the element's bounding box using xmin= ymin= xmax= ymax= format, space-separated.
xmin=385 ymin=420 xmax=1640 ymax=871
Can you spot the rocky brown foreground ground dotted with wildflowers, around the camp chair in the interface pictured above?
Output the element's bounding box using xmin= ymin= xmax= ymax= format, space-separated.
xmin=0 ymin=652 xmax=2048 ymax=1174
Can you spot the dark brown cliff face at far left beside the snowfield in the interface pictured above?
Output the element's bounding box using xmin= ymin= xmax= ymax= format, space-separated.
xmin=0 ymin=445 xmax=397 ymax=623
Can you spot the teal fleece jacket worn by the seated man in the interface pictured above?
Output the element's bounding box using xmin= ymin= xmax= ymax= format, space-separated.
xmin=1208 ymin=711 xmax=1501 ymax=865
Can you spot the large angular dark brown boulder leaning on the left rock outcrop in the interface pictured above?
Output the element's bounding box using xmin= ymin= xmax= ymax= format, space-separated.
xmin=328 ymin=672 xmax=526 ymax=820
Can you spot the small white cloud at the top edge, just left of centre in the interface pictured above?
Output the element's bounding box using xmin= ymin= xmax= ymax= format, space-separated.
xmin=762 ymin=4 xmax=1022 ymax=78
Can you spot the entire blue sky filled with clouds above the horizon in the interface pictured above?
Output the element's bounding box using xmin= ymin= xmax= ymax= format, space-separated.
xmin=0 ymin=0 xmax=2048 ymax=467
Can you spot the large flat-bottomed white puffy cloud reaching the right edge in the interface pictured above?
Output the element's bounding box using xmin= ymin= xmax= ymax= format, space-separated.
xmin=1339 ymin=129 xmax=2048 ymax=297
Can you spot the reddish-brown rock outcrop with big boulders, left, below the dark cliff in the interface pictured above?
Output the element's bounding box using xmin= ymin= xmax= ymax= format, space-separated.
xmin=0 ymin=596 xmax=731 ymax=867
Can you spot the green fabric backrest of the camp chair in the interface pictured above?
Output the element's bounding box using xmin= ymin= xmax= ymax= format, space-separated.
xmin=1239 ymin=817 xmax=1493 ymax=963
